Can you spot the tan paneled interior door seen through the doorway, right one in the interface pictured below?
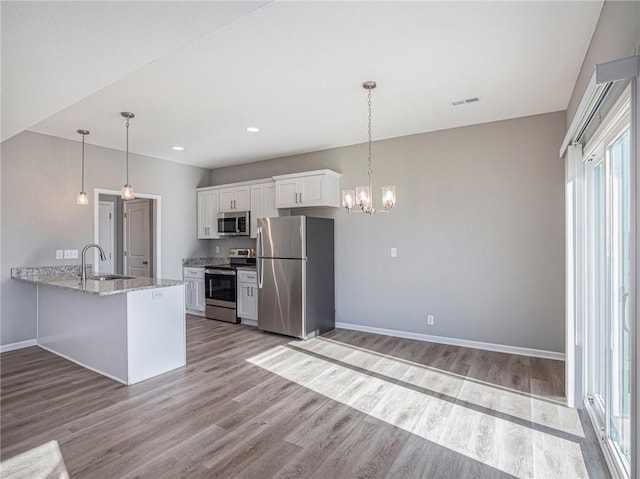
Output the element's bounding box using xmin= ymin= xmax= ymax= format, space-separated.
xmin=124 ymin=199 xmax=152 ymax=276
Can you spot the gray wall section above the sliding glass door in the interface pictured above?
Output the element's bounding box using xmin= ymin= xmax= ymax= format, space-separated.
xmin=566 ymin=1 xmax=640 ymax=128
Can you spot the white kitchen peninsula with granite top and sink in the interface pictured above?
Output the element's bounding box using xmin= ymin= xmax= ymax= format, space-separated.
xmin=11 ymin=266 xmax=186 ymax=385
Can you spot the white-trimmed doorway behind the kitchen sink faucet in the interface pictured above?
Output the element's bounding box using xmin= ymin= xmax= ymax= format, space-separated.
xmin=93 ymin=188 xmax=161 ymax=278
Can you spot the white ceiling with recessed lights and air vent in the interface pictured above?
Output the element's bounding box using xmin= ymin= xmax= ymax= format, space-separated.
xmin=2 ymin=1 xmax=602 ymax=168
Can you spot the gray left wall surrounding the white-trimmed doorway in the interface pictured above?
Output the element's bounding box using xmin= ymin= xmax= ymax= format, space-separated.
xmin=0 ymin=132 xmax=210 ymax=344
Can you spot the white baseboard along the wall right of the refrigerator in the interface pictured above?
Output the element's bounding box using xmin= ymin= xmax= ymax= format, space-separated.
xmin=336 ymin=322 xmax=564 ymax=361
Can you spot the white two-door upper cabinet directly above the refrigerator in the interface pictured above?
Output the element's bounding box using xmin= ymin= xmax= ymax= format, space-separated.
xmin=273 ymin=170 xmax=342 ymax=208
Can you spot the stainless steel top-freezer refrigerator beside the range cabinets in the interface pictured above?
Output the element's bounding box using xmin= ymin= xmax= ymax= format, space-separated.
xmin=256 ymin=216 xmax=335 ymax=339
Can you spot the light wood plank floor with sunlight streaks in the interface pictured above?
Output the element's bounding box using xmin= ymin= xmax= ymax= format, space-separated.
xmin=1 ymin=316 xmax=609 ymax=479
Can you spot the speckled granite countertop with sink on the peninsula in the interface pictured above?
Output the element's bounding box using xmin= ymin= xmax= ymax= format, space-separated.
xmin=11 ymin=265 xmax=184 ymax=296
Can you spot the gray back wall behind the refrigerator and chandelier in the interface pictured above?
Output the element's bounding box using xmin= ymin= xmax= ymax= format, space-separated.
xmin=211 ymin=112 xmax=565 ymax=352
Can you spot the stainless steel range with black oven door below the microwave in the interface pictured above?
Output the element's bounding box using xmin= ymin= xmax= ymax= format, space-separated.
xmin=204 ymin=248 xmax=256 ymax=323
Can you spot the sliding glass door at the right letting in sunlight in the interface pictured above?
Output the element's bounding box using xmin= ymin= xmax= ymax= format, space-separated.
xmin=584 ymin=89 xmax=632 ymax=477
